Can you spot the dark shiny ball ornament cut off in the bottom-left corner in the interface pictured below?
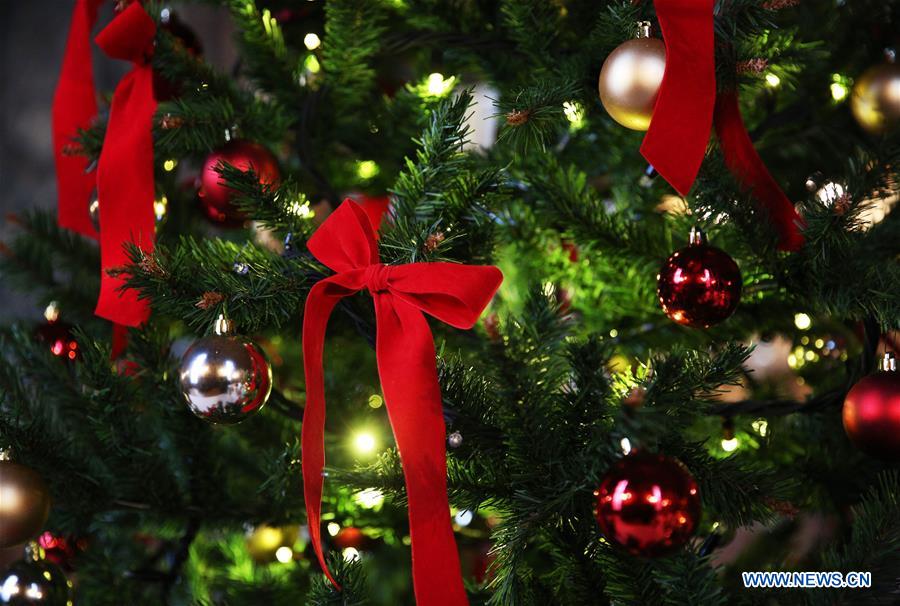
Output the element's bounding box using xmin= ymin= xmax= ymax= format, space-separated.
xmin=0 ymin=543 xmax=72 ymax=606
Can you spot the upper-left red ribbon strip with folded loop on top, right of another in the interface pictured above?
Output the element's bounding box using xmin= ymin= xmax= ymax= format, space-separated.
xmin=95 ymin=2 xmax=156 ymax=326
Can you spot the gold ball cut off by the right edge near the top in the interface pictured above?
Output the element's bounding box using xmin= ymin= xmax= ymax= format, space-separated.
xmin=850 ymin=63 xmax=900 ymax=135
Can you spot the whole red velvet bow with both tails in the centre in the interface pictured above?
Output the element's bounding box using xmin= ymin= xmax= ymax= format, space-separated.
xmin=301 ymin=200 xmax=503 ymax=606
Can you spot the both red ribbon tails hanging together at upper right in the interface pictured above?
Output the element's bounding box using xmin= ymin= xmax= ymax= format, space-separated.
xmin=641 ymin=0 xmax=803 ymax=250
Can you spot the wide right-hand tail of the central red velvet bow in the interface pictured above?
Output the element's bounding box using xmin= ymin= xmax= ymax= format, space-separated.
xmin=375 ymin=294 xmax=469 ymax=606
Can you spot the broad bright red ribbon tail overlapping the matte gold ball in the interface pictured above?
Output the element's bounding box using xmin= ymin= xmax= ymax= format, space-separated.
xmin=641 ymin=0 xmax=716 ymax=196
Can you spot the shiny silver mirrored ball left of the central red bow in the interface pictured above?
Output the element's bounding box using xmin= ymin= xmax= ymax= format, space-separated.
xmin=179 ymin=316 xmax=272 ymax=424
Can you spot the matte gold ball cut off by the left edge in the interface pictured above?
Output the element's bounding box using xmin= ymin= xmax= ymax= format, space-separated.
xmin=0 ymin=453 xmax=50 ymax=548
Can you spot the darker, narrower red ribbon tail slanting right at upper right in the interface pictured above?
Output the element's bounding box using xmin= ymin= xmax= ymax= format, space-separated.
xmin=715 ymin=91 xmax=803 ymax=251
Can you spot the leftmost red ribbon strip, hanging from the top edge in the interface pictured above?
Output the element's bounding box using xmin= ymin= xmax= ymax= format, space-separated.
xmin=52 ymin=0 xmax=103 ymax=238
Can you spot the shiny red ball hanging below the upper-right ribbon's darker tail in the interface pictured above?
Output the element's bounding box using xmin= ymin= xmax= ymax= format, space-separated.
xmin=656 ymin=229 xmax=741 ymax=328
